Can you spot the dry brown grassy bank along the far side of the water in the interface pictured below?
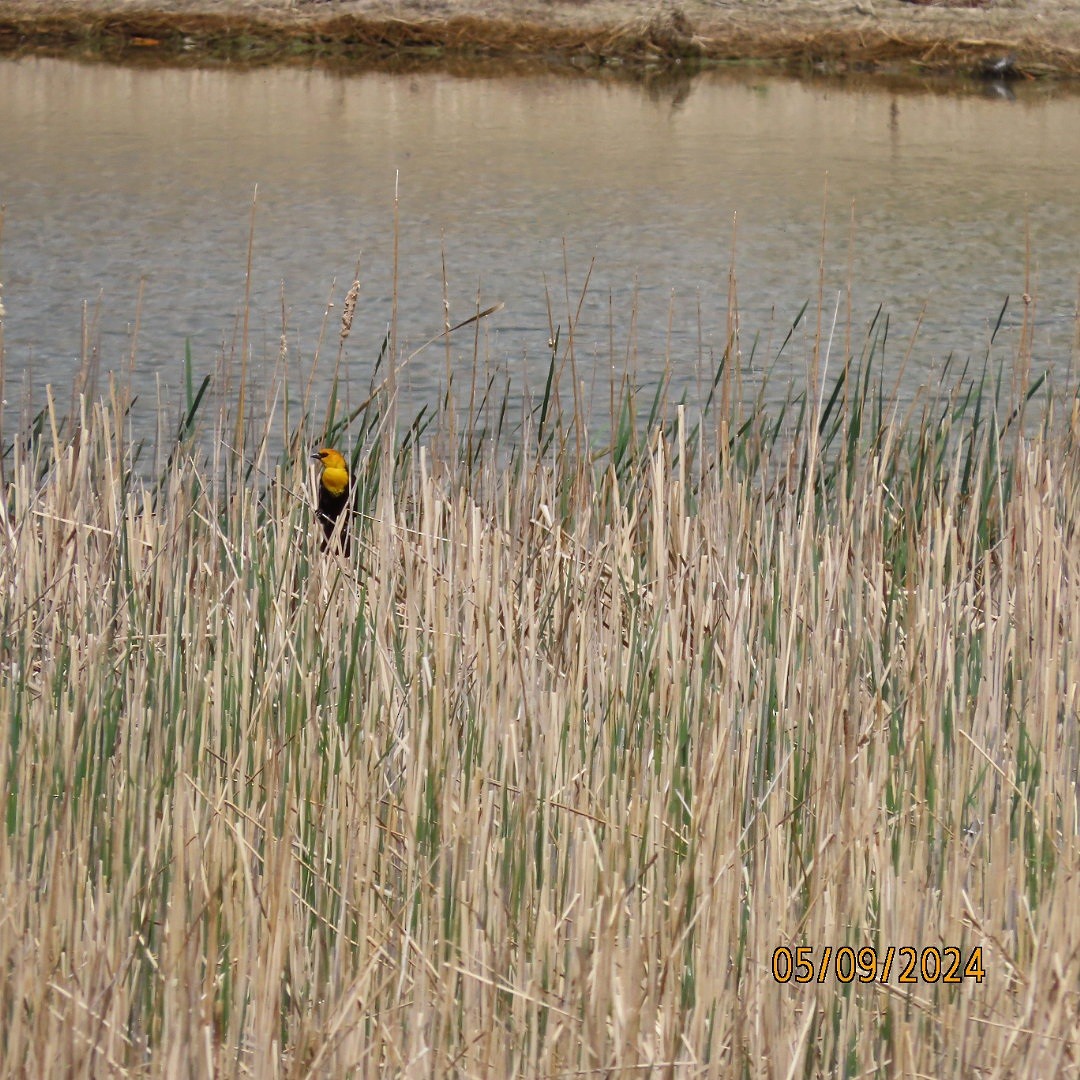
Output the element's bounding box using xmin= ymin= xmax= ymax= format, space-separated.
xmin=0 ymin=0 xmax=1080 ymax=80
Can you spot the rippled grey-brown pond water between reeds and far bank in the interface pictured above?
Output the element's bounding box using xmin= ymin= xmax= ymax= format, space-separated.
xmin=0 ymin=59 xmax=1080 ymax=434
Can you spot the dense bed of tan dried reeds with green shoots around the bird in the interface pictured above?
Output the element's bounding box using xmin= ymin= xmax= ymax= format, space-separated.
xmin=0 ymin=300 xmax=1080 ymax=1078
